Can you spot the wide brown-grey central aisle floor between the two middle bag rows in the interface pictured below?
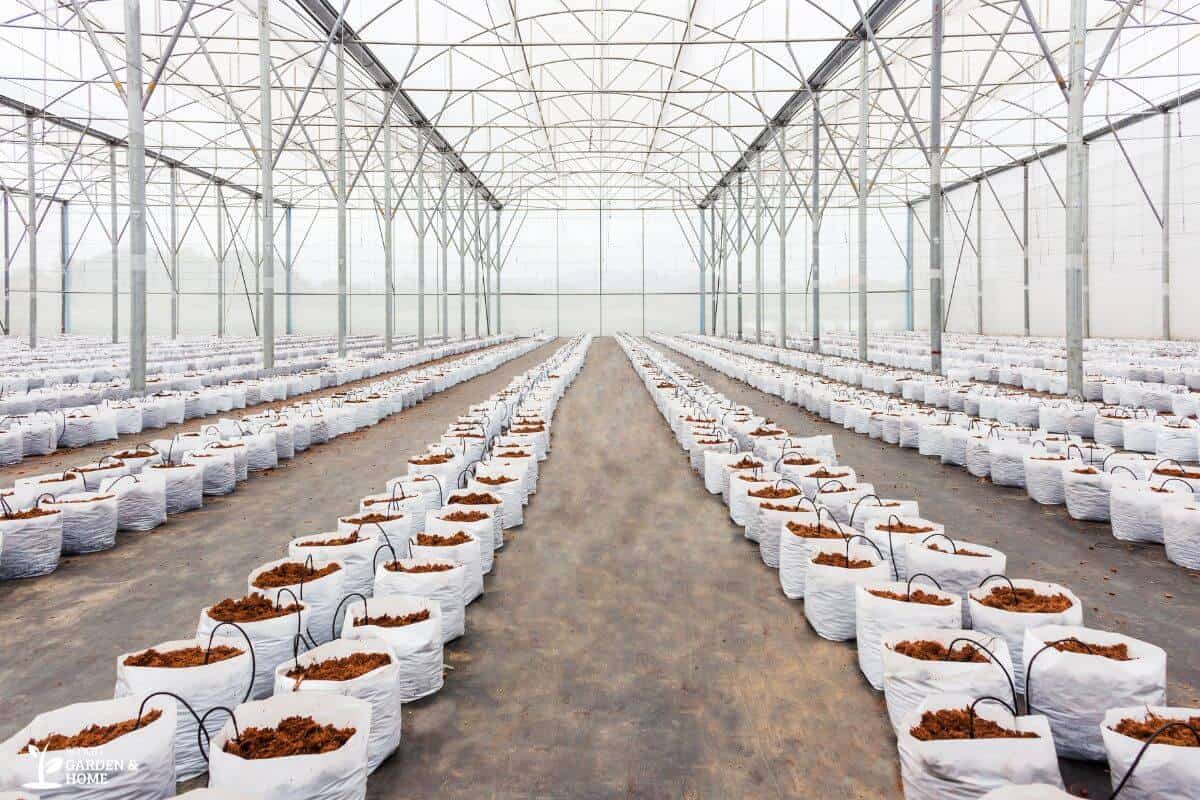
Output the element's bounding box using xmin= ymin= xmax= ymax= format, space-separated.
xmin=384 ymin=337 xmax=900 ymax=799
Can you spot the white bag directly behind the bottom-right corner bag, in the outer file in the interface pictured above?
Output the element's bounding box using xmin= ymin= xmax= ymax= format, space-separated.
xmin=1022 ymin=625 xmax=1166 ymax=762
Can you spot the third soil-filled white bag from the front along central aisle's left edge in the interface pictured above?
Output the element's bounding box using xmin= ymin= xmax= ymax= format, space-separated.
xmin=342 ymin=595 xmax=444 ymax=703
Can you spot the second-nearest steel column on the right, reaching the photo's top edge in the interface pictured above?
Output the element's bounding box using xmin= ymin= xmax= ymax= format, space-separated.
xmin=929 ymin=0 xmax=944 ymax=374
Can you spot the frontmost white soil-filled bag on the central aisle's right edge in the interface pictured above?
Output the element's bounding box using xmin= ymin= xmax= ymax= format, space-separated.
xmin=896 ymin=694 xmax=1062 ymax=800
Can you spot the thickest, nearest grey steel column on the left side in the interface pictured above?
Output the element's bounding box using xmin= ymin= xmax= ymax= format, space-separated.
xmin=125 ymin=0 xmax=146 ymax=395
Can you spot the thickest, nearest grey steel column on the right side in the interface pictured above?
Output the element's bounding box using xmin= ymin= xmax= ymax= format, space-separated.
xmin=1066 ymin=0 xmax=1087 ymax=399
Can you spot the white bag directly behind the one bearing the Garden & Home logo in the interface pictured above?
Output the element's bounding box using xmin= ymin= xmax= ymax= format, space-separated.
xmin=114 ymin=626 xmax=254 ymax=781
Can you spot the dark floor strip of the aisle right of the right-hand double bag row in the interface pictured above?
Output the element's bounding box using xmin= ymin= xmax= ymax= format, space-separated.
xmin=670 ymin=340 xmax=1200 ymax=798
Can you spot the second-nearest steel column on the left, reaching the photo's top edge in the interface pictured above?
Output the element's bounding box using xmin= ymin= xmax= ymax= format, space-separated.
xmin=258 ymin=0 xmax=275 ymax=369
